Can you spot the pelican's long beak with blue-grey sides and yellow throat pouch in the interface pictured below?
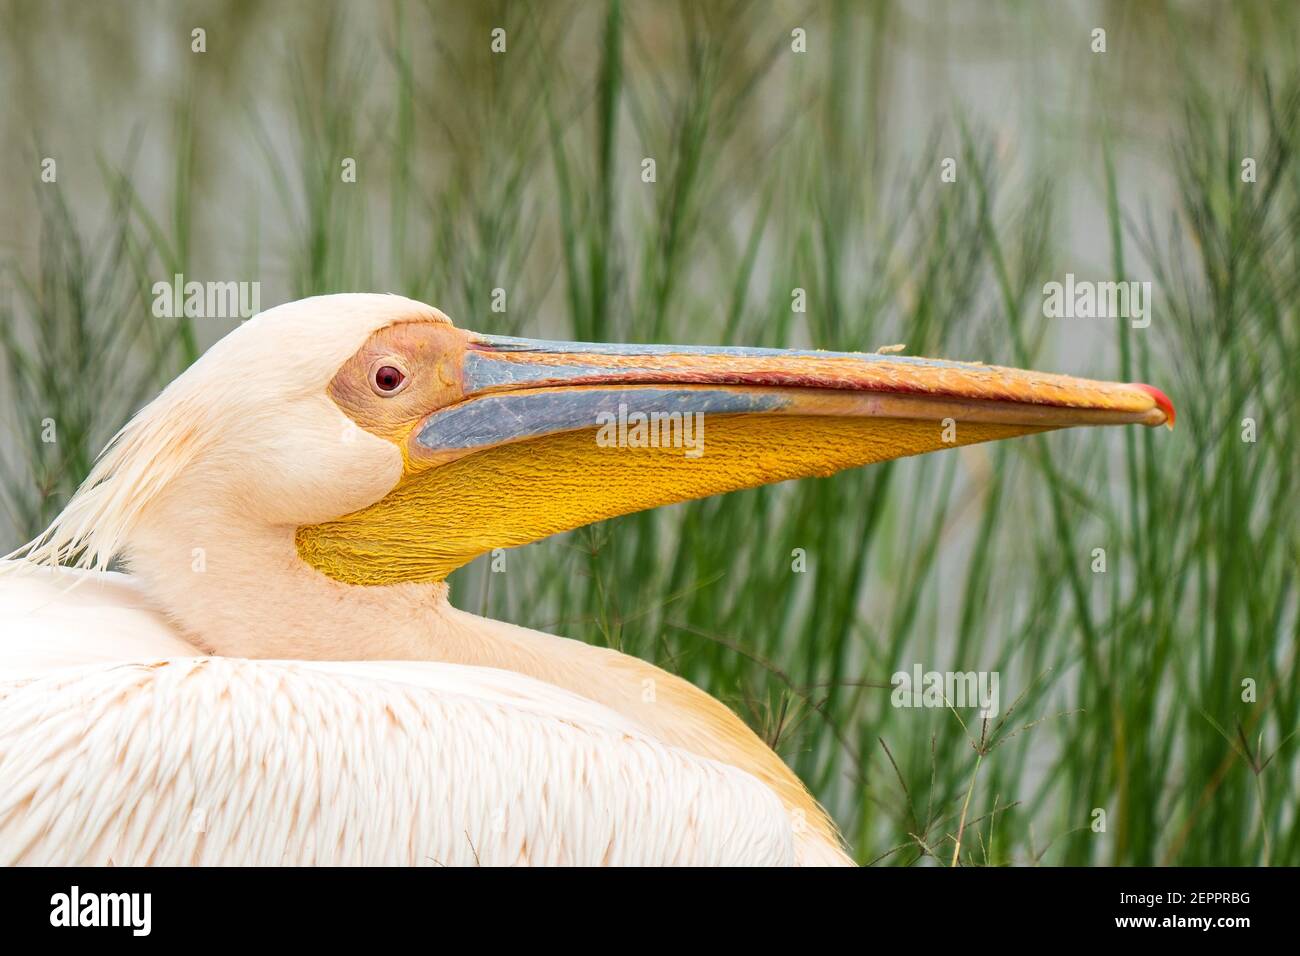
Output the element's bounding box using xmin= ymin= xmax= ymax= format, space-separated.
xmin=298 ymin=333 xmax=1174 ymax=584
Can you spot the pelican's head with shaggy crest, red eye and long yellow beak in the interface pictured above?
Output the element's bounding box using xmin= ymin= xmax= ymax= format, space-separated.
xmin=29 ymin=294 xmax=1174 ymax=613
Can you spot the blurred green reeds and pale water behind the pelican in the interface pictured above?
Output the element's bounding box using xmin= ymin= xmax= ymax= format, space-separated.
xmin=0 ymin=0 xmax=1300 ymax=865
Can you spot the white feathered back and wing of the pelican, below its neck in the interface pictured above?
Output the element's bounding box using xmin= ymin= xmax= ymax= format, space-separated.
xmin=0 ymin=572 xmax=794 ymax=865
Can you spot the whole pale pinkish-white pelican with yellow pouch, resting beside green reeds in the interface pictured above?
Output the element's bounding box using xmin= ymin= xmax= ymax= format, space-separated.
xmin=0 ymin=294 xmax=1174 ymax=865
